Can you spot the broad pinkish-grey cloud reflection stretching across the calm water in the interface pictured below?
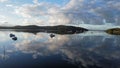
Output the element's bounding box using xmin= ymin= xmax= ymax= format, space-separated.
xmin=0 ymin=33 xmax=120 ymax=68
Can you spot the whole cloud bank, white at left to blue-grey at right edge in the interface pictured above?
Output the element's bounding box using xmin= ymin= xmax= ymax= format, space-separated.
xmin=16 ymin=0 xmax=120 ymax=25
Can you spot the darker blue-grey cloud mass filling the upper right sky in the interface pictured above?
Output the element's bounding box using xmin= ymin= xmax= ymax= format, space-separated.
xmin=64 ymin=0 xmax=120 ymax=24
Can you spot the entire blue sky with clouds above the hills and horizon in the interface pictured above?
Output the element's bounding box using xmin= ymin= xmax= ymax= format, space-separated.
xmin=0 ymin=0 xmax=120 ymax=27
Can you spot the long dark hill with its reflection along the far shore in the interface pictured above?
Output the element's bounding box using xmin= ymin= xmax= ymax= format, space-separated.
xmin=0 ymin=25 xmax=88 ymax=34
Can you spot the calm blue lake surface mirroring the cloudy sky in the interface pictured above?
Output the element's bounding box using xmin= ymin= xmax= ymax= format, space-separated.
xmin=0 ymin=31 xmax=120 ymax=68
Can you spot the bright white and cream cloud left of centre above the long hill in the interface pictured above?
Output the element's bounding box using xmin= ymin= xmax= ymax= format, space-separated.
xmin=16 ymin=3 xmax=69 ymax=25
